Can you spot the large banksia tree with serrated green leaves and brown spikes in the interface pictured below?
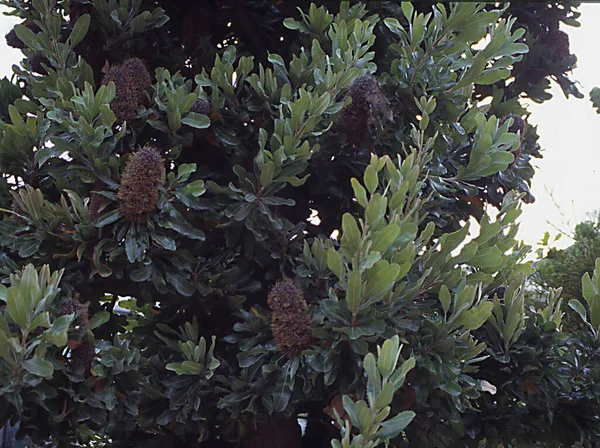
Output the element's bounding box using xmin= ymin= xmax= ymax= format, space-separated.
xmin=0 ymin=0 xmax=599 ymax=448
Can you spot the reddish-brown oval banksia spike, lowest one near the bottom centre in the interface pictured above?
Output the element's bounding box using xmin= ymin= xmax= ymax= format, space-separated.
xmin=268 ymin=280 xmax=312 ymax=358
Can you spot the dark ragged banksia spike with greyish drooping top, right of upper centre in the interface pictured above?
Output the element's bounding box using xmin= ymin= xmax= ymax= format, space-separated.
xmin=335 ymin=75 xmax=393 ymax=146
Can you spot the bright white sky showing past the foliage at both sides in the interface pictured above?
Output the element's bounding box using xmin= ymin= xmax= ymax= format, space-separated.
xmin=0 ymin=4 xmax=600 ymax=254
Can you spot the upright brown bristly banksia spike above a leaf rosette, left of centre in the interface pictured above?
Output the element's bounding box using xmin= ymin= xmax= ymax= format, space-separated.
xmin=117 ymin=146 xmax=165 ymax=224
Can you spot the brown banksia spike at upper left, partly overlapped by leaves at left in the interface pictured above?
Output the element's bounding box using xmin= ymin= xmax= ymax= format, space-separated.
xmin=102 ymin=58 xmax=152 ymax=123
